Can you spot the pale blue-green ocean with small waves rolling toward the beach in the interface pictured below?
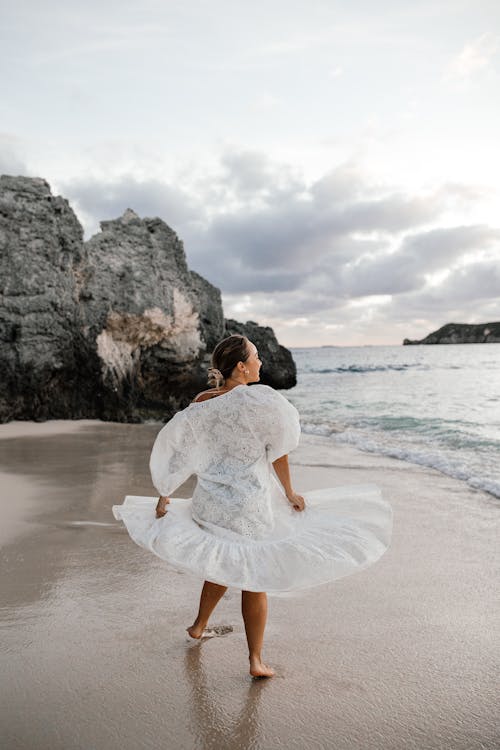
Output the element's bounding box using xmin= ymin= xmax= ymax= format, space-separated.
xmin=284 ymin=344 xmax=500 ymax=497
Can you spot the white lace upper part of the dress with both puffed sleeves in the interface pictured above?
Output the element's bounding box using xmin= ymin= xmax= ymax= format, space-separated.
xmin=150 ymin=385 xmax=300 ymax=538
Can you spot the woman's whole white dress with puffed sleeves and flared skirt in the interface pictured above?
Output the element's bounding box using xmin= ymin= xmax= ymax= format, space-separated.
xmin=113 ymin=384 xmax=392 ymax=594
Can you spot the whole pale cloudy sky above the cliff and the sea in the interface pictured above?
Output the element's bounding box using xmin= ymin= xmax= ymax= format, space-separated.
xmin=0 ymin=0 xmax=500 ymax=347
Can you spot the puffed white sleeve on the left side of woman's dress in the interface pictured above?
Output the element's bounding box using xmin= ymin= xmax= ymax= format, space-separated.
xmin=149 ymin=412 xmax=196 ymax=496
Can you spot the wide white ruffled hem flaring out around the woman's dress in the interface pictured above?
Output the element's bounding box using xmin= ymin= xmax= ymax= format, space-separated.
xmin=112 ymin=485 xmax=392 ymax=595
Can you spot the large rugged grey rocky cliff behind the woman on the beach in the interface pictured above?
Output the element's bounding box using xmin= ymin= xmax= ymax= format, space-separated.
xmin=0 ymin=176 xmax=295 ymax=422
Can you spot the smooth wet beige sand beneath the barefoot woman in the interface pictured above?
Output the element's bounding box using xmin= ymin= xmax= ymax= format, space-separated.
xmin=0 ymin=421 xmax=500 ymax=750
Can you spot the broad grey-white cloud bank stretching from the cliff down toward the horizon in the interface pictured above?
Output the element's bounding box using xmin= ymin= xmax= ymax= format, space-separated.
xmin=52 ymin=149 xmax=500 ymax=343
